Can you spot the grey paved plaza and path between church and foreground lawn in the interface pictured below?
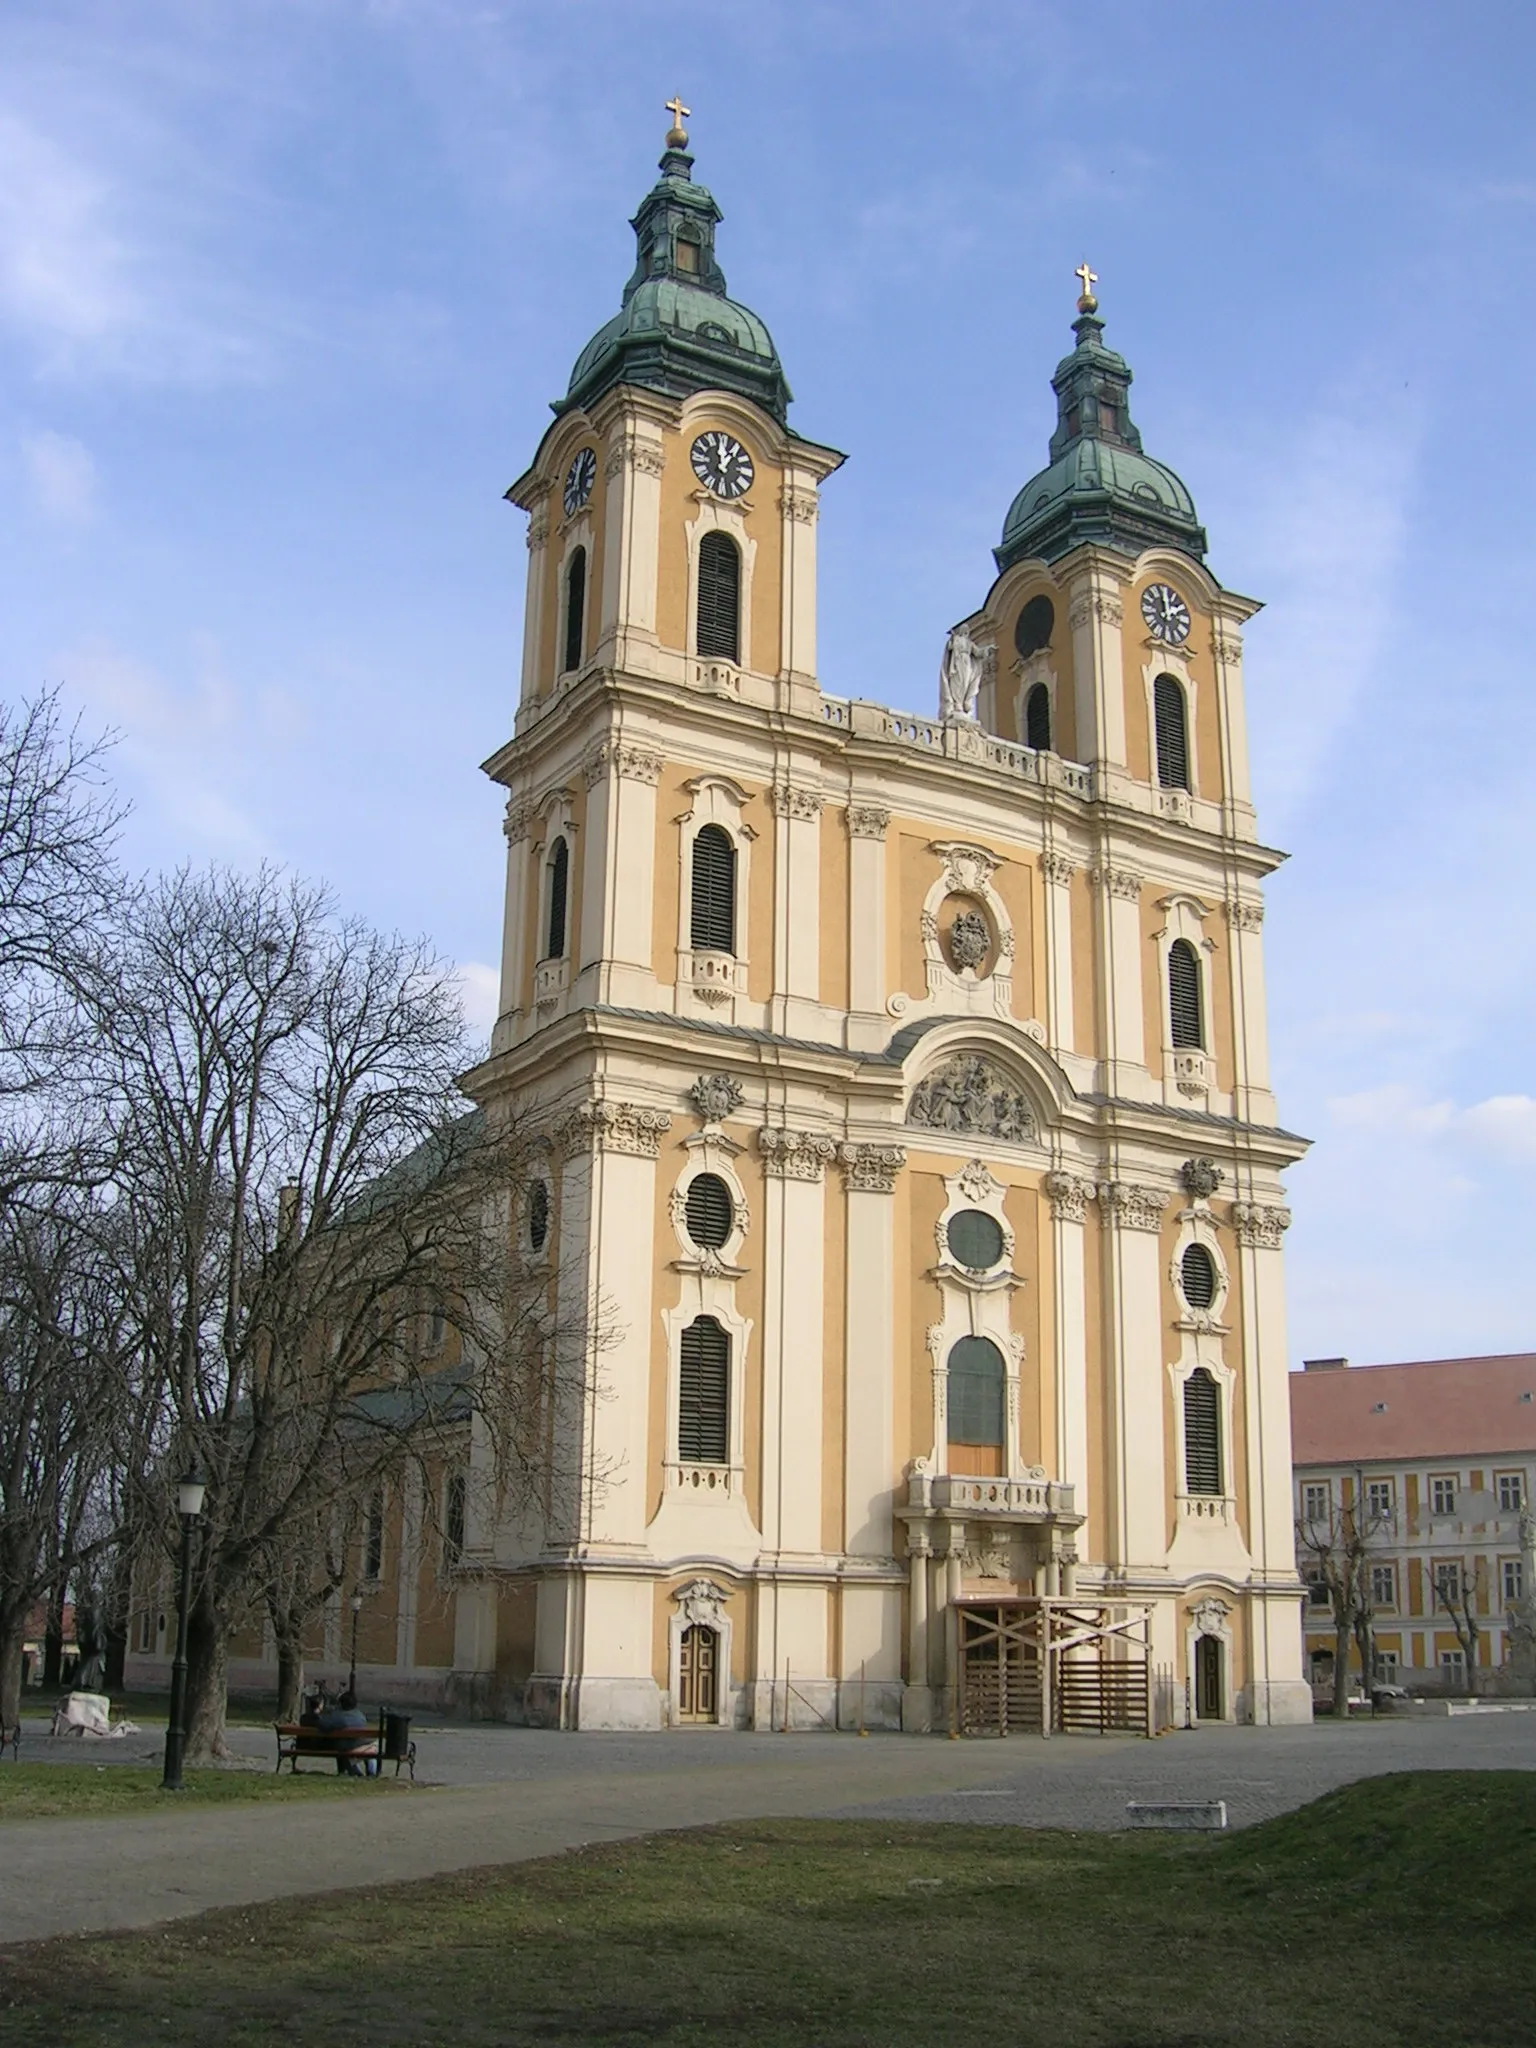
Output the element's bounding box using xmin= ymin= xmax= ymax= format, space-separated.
xmin=0 ymin=1712 xmax=1536 ymax=1942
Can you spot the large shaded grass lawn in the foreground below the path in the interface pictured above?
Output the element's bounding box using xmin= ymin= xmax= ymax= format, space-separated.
xmin=0 ymin=1772 xmax=1536 ymax=2048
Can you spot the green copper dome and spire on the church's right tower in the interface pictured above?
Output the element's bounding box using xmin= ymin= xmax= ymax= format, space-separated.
xmin=993 ymin=299 xmax=1206 ymax=569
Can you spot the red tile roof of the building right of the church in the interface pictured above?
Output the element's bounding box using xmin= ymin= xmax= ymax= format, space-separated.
xmin=1290 ymin=1352 xmax=1536 ymax=1464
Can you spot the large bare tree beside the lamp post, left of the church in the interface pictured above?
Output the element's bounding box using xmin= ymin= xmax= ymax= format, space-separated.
xmin=98 ymin=870 xmax=592 ymax=1757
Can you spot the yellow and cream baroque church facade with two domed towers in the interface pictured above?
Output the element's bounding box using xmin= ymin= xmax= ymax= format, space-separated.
xmin=448 ymin=127 xmax=1311 ymax=1731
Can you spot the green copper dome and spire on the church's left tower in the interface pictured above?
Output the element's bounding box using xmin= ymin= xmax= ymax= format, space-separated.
xmin=553 ymin=137 xmax=791 ymax=420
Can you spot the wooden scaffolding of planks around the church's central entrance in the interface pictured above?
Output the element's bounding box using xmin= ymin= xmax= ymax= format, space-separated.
xmin=952 ymin=1595 xmax=1157 ymax=1735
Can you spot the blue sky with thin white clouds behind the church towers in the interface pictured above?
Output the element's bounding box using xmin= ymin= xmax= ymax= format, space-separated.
xmin=0 ymin=0 xmax=1536 ymax=1362
